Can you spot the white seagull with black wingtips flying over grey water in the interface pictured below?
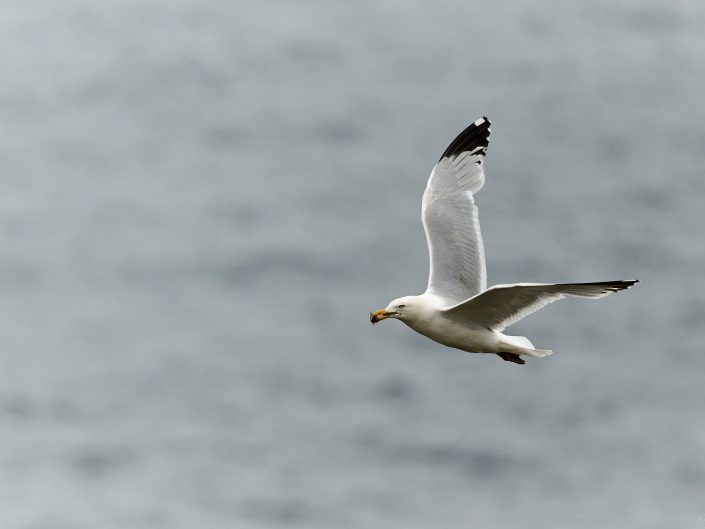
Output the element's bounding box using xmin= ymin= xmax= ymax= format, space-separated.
xmin=370 ymin=117 xmax=639 ymax=364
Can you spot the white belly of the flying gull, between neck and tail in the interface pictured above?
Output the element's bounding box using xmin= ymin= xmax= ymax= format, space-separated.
xmin=409 ymin=318 xmax=499 ymax=353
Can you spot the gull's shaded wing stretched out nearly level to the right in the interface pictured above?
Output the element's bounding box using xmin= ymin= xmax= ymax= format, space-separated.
xmin=445 ymin=279 xmax=639 ymax=331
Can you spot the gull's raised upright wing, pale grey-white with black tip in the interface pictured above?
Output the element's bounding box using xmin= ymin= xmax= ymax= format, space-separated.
xmin=421 ymin=117 xmax=490 ymax=305
